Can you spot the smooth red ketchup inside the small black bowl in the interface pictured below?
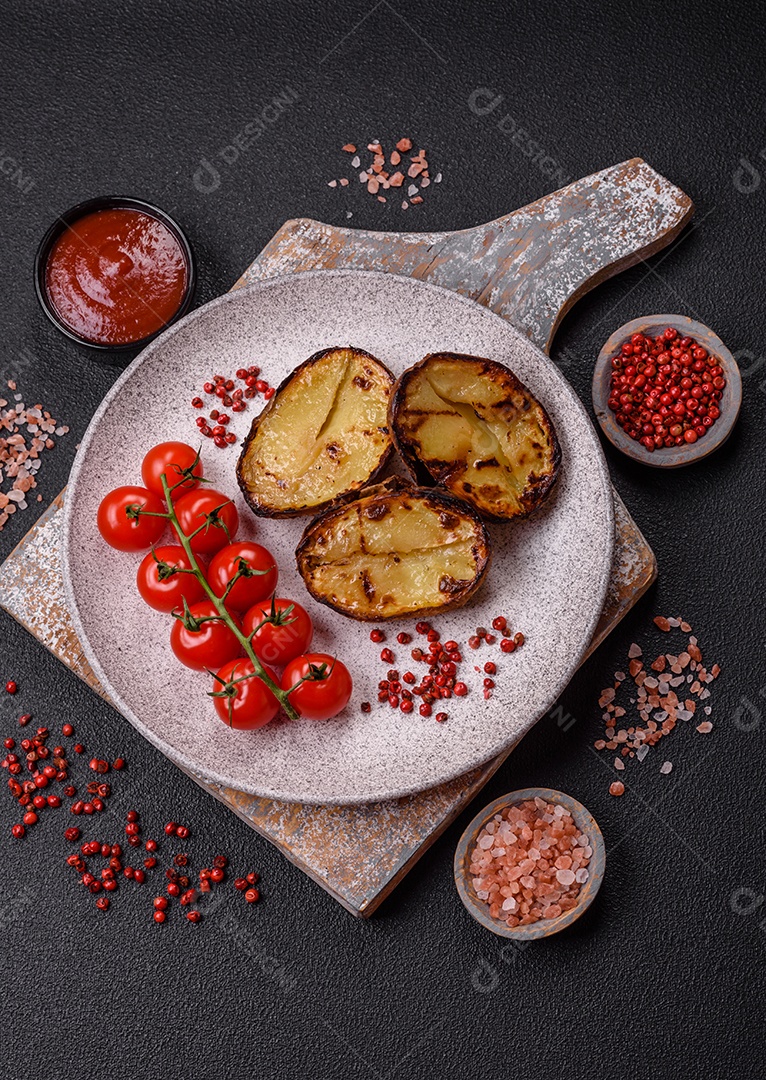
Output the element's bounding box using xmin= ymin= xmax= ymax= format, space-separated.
xmin=45 ymin=208 xmax=189 ymax=346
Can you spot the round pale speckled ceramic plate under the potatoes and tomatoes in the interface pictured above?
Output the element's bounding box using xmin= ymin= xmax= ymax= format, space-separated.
xmin=64 ymin=271 xmax=614 ymax=804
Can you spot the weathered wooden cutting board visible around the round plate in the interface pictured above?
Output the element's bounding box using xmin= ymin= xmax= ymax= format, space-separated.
xmin=0 ymin=158 xmax=694 ymax=917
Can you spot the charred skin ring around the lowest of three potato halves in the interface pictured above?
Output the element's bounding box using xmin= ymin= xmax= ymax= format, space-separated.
xmin=295 ymin=486 xmax=492 ymax=622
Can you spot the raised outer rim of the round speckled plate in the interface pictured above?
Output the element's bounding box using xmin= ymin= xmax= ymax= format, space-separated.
xmin=62 ymin=269 xmax=615 ymax=806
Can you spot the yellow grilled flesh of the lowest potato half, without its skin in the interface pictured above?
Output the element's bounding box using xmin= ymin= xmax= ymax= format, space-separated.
xmin=305 ymin=499 xmax=479 ymax=618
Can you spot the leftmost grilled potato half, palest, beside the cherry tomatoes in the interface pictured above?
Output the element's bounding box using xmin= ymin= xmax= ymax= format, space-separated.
xmin=237 ymin=348 xmax=394 ymax=517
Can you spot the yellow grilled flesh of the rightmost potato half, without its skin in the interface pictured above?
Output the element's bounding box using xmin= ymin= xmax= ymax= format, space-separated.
xmin=404 ymin=361 xmax=551 ymax=513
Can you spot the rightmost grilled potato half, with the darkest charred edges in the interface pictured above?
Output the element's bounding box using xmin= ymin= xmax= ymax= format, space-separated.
xmin=389 ymin=352 xmax=561 ymax=521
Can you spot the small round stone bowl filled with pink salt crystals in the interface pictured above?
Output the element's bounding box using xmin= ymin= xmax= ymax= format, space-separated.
xmin=455 ymin=787 xmax=606 ymax=941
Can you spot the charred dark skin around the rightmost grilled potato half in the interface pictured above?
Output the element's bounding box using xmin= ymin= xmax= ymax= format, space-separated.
xmin=388 ymin=352 xmax=561 ymax=524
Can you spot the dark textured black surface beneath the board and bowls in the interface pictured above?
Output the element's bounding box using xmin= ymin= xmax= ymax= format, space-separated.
xmin=0 ymin=0 xmax=766 ymax=1080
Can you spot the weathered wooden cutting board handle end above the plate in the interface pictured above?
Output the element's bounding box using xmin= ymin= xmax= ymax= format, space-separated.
xmin=243 ymin=158 xmax=694 ymax=351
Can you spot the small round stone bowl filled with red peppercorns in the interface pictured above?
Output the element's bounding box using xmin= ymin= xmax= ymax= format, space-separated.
xmin=593 ymin=315 xmax=742 ymax=469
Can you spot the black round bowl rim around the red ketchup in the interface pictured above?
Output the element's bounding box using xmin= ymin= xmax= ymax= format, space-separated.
xmin=35 ymin=195 xmax=197 ymax=353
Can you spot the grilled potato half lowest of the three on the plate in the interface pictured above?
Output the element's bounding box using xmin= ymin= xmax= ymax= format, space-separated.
xmin=296 ymin=486 xmax=489 ymax=621
